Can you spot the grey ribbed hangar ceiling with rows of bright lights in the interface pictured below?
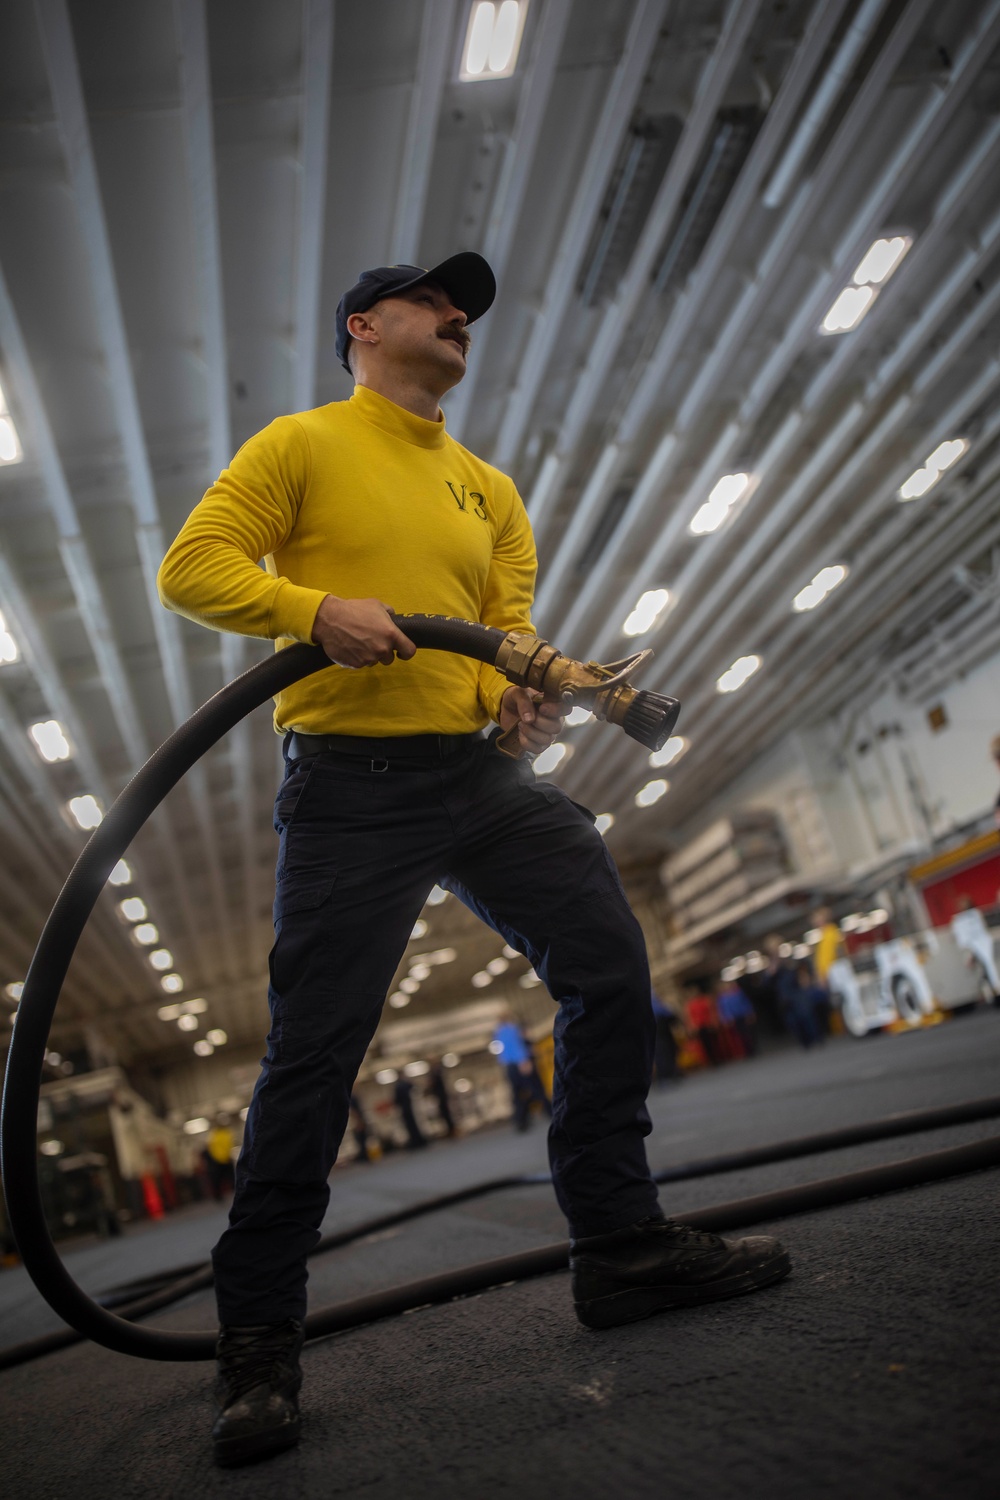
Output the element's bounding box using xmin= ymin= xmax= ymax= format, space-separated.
xmin=0 ymin=0 xmax=1000 ymax=1061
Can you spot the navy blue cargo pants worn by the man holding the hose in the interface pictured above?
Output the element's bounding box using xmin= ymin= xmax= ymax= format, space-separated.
xmin=213 ymin=735 xmax=658 ymax=1325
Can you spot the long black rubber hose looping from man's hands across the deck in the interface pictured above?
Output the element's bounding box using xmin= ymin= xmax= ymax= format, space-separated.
xmin=0 ymin=615 xmax=1000 ymax=1365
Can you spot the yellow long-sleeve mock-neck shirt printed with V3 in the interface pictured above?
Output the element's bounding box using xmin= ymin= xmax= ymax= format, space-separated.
xmin=157 ymin=386 xmax=535 ymax=735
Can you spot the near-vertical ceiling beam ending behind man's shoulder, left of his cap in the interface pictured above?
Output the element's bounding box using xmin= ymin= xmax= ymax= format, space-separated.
xmin=292 ymin=0 xmax=333 ymax=411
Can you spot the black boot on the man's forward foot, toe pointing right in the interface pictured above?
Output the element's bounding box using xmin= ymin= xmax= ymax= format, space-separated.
xmin=570 ymin=1218 xmax=792 ymax=1328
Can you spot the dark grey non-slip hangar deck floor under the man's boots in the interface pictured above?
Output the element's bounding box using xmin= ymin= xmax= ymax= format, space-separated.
xmin=0 ymin=1010 xmax=1000 ymax=1500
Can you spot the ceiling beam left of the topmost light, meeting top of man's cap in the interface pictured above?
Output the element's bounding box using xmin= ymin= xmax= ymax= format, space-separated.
xmin=390 ymin=0 xmax=457 ymax=266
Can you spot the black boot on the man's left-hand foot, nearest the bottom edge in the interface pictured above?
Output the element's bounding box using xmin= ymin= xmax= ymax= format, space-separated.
xmin=211 ymin=1319 xmax=304 ymax=1469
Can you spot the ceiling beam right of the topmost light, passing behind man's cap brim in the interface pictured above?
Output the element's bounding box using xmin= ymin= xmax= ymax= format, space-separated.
xmin=448 ymin=0 xmax=573 ymax=435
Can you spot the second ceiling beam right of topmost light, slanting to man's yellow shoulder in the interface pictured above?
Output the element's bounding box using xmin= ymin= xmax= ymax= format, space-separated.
xmin=493 ymin=0 xmax=667 ymax=470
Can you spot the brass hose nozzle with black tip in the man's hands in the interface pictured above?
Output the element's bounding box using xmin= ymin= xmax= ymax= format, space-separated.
xmin=496 ymin=630 xmax=681 ymax=759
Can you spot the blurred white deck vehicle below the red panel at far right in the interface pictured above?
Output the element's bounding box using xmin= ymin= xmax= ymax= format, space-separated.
xmin=826 ymin=927 xmax=988 ymax=1037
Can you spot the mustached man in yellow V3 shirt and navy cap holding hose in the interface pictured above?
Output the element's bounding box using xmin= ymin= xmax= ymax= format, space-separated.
xmin=160 ymin=252 xmax=789 ymax=1466
